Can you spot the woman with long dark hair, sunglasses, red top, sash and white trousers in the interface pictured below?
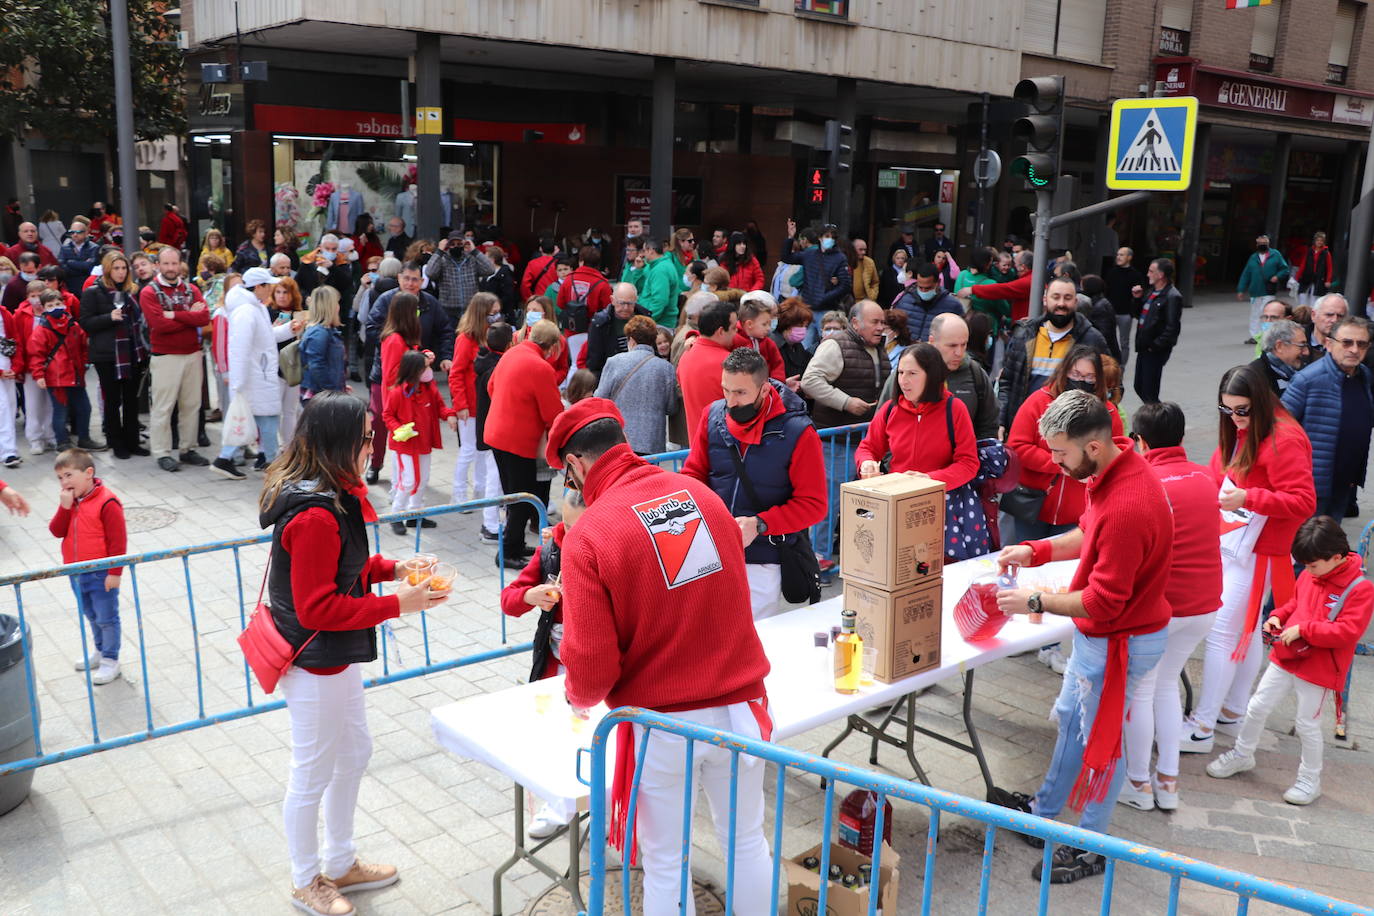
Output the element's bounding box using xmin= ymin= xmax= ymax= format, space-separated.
xmin=1179 ymin=365 xmax=1316 ymax=754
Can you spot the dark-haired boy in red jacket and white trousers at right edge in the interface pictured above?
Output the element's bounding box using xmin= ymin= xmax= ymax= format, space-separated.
xmin=1206 ymin=515 xmax=1374 ymax=805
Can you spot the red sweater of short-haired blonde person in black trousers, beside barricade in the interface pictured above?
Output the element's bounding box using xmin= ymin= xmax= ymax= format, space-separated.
xmin=482 ymin=341 xmax=563 ymax=459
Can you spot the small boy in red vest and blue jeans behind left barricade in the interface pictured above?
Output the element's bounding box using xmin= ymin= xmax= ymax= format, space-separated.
xmin=48 ymin=449 xmax=129 ymax=684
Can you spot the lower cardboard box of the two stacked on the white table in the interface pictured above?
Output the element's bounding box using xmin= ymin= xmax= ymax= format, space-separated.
xmin=844 ymin=577 xmax=944 ymax=684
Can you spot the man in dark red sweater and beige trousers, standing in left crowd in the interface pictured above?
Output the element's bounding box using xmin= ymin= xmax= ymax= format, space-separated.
xmin=139 ymin=247 xmax=208 ymax=471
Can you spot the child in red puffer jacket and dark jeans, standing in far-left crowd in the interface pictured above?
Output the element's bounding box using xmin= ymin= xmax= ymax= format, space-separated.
xmin=29 ymin=290 xmax=104 ymax=452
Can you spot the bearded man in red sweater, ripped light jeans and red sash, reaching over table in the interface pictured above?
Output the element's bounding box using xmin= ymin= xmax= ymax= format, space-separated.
xmin=998 ymin=390 xmax=1173 ymax=884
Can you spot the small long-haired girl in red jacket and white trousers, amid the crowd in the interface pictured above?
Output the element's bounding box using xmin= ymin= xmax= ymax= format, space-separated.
xmin=382 ymin=350 xmax=458 ymax=534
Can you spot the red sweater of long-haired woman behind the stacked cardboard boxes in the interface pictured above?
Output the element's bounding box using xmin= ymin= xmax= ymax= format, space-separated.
xmin=855 ymin=391 xmax=978 ymax=490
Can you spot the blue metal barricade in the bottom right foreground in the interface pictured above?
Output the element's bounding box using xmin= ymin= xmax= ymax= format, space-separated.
xmin=585 ymin=707 xmax=1374 ymax=916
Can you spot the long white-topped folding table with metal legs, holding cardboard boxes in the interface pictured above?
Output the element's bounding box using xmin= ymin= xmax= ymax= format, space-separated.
xmin=430 ymin=558 xmax=1077 ymax=916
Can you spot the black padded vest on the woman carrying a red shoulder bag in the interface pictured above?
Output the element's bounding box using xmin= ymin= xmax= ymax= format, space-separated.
xmin=264 ymin=485 xmax=376 ymax=667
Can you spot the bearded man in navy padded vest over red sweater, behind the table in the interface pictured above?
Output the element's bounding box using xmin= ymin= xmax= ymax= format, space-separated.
xmin=683 ymin=347 xmax=827 ymax=621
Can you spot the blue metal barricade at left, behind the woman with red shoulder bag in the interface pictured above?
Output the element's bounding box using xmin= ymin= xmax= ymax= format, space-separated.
xmin=0 ymin=493 xmax=548 ymax=776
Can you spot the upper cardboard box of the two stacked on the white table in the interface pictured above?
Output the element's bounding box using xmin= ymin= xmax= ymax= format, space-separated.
xmin=840 ymin=474 xmax=944 ymax=592
